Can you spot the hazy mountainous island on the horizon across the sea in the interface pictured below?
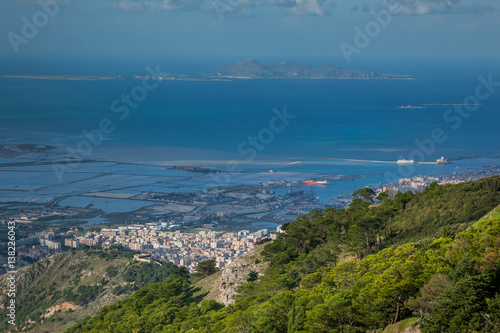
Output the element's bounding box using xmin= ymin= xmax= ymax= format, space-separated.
xmin=214 ymin=60 xmax=394 ymax=79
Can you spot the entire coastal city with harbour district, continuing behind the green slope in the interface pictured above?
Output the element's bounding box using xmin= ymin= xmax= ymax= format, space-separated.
xmin=0 ymin=165 xmax=500 ymax=271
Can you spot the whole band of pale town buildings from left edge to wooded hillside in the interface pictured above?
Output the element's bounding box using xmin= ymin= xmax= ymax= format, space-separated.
xmin=0 ymin=222 xmax=283 ymax=272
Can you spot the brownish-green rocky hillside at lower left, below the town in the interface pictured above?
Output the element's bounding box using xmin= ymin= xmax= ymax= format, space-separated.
xmin=0 ymin=250 xmax=175 ymax=333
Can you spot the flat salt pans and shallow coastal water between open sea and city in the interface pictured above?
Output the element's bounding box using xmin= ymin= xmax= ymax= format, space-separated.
xmin=0 ymin=144 xmax=500 ymax=215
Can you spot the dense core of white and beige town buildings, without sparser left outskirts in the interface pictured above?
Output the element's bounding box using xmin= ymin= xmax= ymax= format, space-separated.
xmin=65 ymin=222 xmax=282 ymax=272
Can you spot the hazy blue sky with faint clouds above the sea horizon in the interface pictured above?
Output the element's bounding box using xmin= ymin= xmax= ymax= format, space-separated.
xmin=0 ymin=0 xmax=500 ymax=71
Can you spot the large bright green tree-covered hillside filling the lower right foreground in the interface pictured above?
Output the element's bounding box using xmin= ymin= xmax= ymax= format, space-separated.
xmin=68 ymin=176 xmax=500 ymax=333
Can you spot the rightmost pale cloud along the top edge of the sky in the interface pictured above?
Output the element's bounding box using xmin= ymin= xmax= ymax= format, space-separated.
xmin=383 ymin=0 xmax=493 ymax=15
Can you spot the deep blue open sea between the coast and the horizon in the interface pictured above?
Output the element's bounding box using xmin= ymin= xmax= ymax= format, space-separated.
xmin=0 ymin=59 xmax=500 ymax=198
